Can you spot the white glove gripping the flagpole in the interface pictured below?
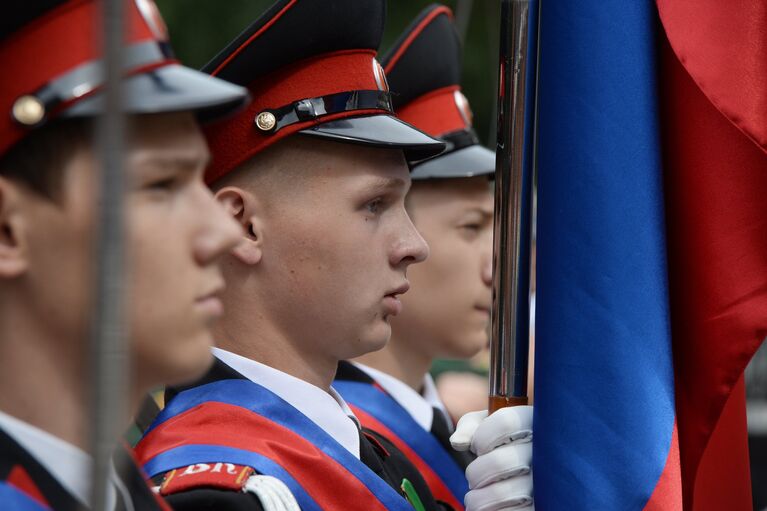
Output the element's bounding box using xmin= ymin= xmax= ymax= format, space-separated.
xmin=450 ymin=406 xmax=533 ymax=511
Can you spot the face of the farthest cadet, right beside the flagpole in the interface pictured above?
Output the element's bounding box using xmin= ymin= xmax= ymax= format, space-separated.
xmin=392 ymin=176 xmax=493 ymax=358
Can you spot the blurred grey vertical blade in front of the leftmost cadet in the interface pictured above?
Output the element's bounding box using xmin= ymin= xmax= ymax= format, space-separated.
xmin=90 ymin=0 xmax=128 ymax=511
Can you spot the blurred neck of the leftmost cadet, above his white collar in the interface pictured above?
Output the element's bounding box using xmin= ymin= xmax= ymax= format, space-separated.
xmin=0 ymin=297 xmax=90 ymax=451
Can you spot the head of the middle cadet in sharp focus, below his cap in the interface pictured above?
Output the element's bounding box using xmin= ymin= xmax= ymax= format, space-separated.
xmin=217 ymin=136 xmax=428 ymax=370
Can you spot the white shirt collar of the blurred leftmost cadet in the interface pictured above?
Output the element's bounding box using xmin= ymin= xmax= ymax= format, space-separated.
xmin=0 ymin=411 xmax=91 ymax=505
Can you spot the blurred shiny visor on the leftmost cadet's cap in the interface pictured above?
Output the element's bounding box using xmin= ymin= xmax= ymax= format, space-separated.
xmin=62 ymin=64 xmax=248 ymax=121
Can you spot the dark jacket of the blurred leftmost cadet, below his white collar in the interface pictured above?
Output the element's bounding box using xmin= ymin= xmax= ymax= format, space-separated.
xmin=0 ymin=429 xmax=168 ymax=511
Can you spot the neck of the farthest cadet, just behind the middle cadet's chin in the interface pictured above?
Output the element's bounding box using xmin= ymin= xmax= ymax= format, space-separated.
xmin=355 ymin=332 xmax=432 ymax=392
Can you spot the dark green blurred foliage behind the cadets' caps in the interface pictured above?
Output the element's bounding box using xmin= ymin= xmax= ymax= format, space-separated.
xmin=156 ymin=0 xmax=499 ymax=147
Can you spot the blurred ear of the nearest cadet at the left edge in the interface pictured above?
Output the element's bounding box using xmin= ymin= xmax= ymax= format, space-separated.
xmin=0 ymin=177 xmax=29 ymax=279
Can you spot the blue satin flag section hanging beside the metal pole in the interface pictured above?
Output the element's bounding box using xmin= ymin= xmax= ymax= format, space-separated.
xmin=533 ymin=0 xmax=681 ymax=510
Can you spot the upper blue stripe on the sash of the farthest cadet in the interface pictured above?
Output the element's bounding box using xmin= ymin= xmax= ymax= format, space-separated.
xmin=333 ymin=380 xmax=469 ymax=502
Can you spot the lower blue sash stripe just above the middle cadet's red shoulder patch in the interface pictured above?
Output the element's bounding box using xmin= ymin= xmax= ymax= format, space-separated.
xmin=144 ymin=444 xmax=322 ymax=511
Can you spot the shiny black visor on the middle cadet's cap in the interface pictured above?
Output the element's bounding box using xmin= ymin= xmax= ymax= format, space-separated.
xmin=299 ymin=114 xmax=445 ymax=162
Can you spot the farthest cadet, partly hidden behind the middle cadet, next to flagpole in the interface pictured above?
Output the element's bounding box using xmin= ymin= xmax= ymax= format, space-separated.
xmin=333 ymin=5 xmax=532 ymax=509
